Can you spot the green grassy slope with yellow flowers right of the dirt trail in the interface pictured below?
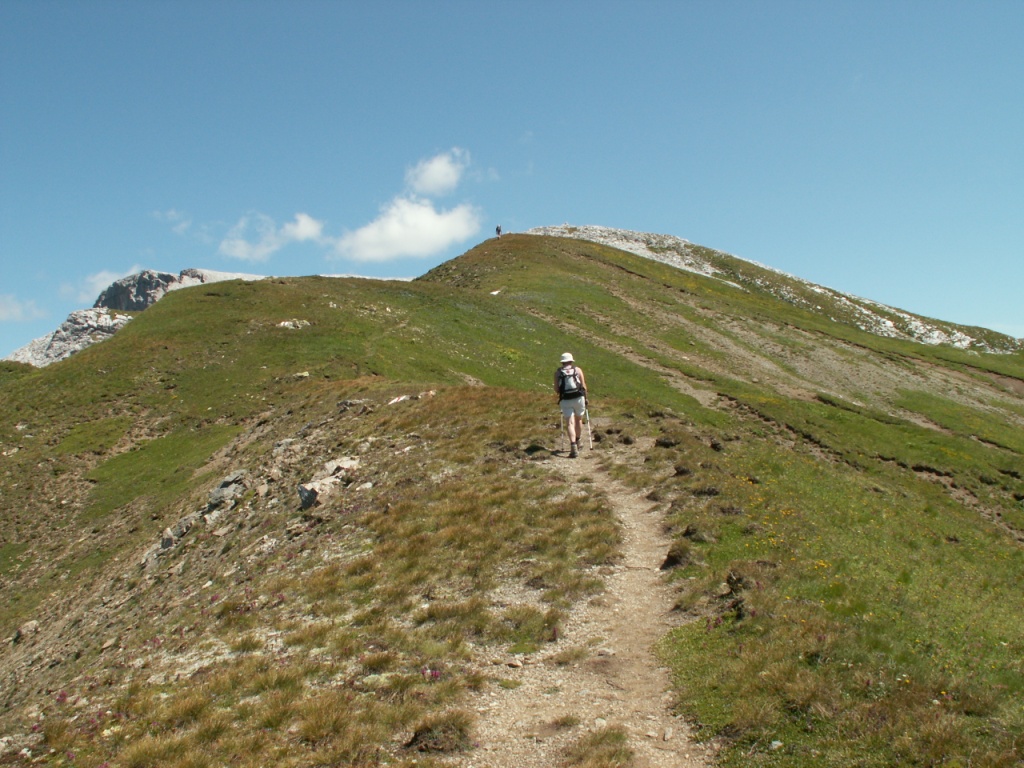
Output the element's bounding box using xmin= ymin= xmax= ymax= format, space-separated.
xmin=643 ymin=434 xmax=1024 ymax=766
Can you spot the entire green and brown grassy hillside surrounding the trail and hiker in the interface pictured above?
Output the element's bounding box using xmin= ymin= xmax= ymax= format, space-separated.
xmin=0 ymin=236 xmax=1024 ymax=766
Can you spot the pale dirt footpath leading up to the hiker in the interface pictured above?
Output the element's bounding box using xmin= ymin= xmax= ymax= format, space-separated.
xmin=445 ymin=434 xmax=714 ymax=768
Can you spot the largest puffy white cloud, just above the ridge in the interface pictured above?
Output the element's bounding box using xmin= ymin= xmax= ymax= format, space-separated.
xmin=336 ymin=198 xmax=480 ymax=261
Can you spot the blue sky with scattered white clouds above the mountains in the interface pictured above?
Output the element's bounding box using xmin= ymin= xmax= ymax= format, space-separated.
xmin=0 ymin=0 xmax=1024 ymax=356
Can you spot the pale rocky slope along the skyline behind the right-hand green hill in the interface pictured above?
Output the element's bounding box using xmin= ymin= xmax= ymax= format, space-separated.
xmin=527 ymin=224 xmax=1024 ymax=352
